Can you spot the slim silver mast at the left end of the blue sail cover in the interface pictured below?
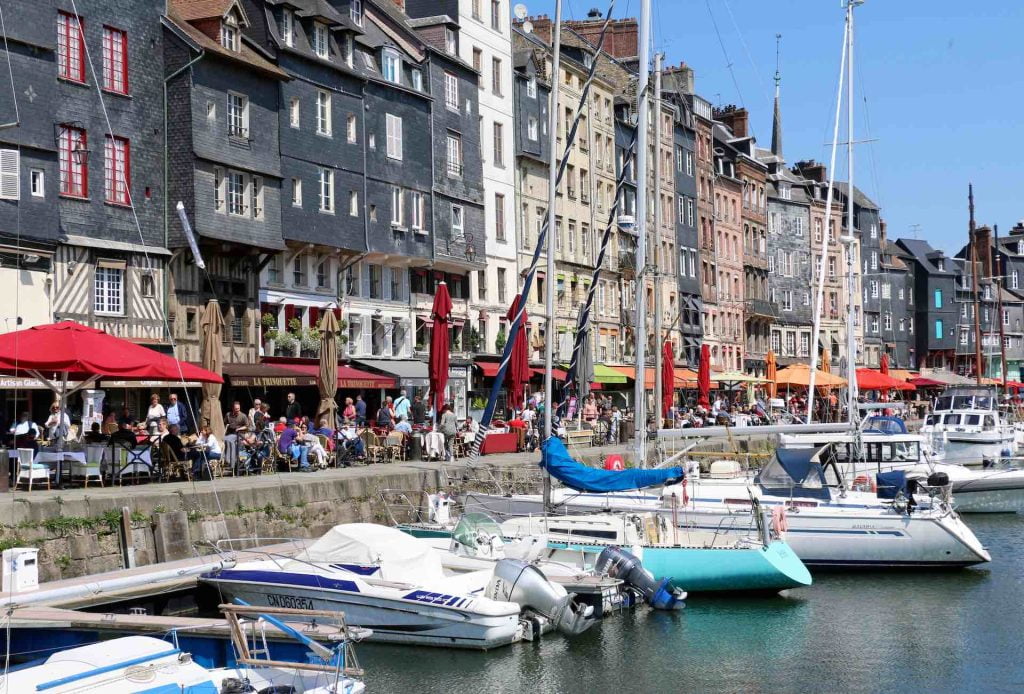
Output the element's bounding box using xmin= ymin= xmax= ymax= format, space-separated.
xmin=544 ymin=0 xmax=568 ymax=509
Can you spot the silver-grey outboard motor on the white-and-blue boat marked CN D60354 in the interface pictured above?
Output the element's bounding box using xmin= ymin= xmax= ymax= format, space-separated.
xmin=484 ymin=559 xmax=595 ymax=636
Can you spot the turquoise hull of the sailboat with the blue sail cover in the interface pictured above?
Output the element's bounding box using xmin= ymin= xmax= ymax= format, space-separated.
xmin=548 ymin=540 xmax=811 ymax=594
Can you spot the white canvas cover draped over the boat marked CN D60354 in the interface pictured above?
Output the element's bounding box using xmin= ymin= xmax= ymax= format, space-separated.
xmin=286 ymin=523 xmax=444 ymax=585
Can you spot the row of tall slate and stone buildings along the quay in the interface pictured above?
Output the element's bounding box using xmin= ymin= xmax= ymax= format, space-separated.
xmin=0 ymin=0 xmax=1011 ymax=419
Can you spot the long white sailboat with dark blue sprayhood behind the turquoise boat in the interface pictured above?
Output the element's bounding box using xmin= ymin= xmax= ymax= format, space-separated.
xmin=465 ymin=449 xmax=991 ymax=568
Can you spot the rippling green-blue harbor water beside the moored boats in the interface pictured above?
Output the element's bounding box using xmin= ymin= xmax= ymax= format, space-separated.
xmin=358 ymin=515 xmax=1024 ymax=694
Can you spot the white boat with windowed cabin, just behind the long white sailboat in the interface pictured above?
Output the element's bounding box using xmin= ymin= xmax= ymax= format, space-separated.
xmin=779 ymin=417 xmax=1024 ymax=513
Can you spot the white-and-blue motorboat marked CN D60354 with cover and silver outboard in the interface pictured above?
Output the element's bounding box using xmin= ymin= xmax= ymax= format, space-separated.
xmin=200 ymin=523 xmax=593 ymax=649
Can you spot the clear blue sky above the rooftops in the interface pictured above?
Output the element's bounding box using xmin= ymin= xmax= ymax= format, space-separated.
xmin=513 ymin=0 xmax=1024 ymax=251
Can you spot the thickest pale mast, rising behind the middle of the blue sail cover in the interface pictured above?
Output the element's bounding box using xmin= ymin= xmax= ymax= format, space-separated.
xmin=633 ymin=0 xmax=650 ymax=468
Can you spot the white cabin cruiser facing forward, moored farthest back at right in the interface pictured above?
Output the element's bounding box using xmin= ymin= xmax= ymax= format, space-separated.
xmin=921 ymin=386 xmax=1015 ymax=465
